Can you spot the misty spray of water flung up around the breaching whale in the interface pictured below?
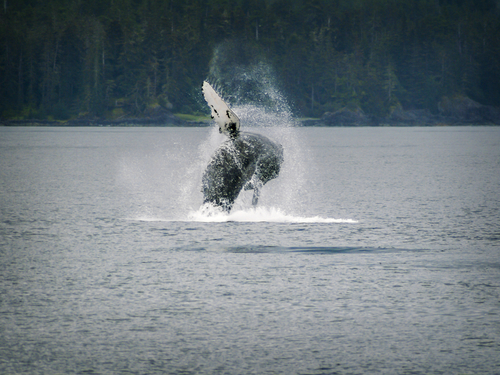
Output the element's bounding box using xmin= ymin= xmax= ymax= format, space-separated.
xmin=188 ymin=42 xmax=310 ymax=216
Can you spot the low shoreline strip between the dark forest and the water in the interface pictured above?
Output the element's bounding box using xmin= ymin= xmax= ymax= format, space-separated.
xmin=0 ymin=96 xmax=500 ymax=127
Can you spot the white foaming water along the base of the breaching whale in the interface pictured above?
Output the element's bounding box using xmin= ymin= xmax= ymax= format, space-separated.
xmin=188 ymin=205 xmax=357 ymax=223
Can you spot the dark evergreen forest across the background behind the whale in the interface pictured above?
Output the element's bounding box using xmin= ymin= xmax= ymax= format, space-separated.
xmin=0 ymin=0 xmax=500 ymax=120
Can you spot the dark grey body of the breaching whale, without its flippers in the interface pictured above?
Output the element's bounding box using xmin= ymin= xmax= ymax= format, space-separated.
xmin=202 ymin=132 xmax=283 ymax=211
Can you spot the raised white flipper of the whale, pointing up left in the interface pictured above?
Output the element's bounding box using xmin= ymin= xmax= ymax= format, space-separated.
xmin=202 ymin=81 xmax=240 ymax=135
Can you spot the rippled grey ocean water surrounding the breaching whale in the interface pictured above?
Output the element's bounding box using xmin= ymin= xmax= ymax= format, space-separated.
xmin=0 ymin=126 xmax=500 ymax=374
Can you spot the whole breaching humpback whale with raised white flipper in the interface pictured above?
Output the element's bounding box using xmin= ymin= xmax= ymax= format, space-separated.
xmin=202 ymin=81 xmax=283 ymax=212
